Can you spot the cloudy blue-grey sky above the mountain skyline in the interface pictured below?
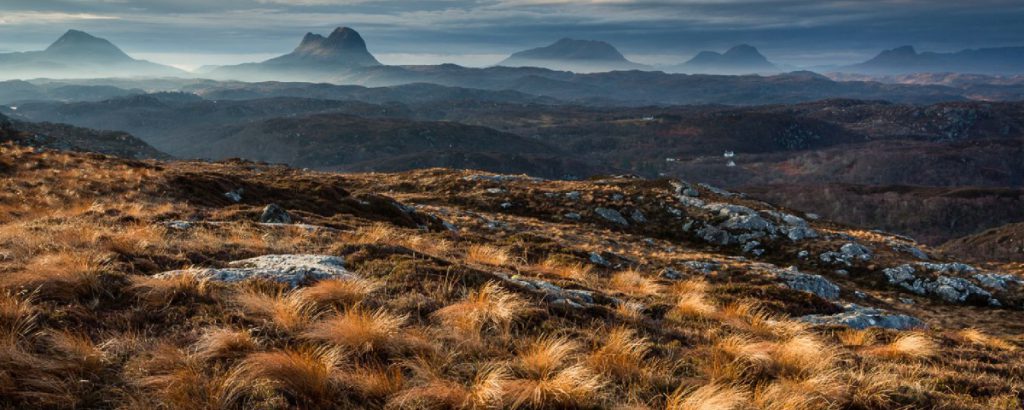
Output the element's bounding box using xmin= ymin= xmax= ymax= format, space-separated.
xmin=0 ymin=0 xmax=1024 ymax=69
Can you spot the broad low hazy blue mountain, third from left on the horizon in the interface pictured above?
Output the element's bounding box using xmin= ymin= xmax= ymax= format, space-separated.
xmin=498 ymin=38 xmax=649 ymax=73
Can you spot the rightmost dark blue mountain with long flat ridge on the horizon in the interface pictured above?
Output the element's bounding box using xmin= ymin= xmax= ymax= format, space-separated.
xmin=838 ymin=45 xmax=1024 ymax=75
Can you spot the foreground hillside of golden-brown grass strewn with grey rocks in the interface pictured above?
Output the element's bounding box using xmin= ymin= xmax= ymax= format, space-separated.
xmin=0 ymin=146 xmax=1024 ymax=409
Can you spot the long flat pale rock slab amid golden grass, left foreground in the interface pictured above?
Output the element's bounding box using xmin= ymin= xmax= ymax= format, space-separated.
xmin=156 ymin=255 xmax=354 ymax=288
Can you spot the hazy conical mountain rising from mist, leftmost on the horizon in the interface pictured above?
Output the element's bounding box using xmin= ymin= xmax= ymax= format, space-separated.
xmin=0 ymin=30 xmax=187 ymax=80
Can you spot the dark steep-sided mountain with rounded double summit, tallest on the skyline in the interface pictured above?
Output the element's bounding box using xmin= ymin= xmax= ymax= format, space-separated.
xmin=205 ymin=27 xmax=382 ymax=80
